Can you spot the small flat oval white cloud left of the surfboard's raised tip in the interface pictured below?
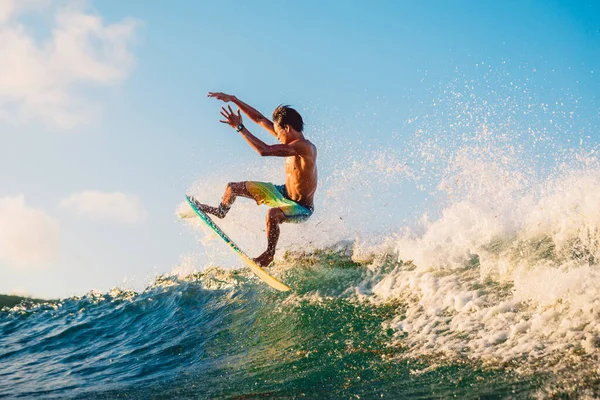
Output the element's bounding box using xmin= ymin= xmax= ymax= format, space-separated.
xmin=60 ymin=190 xmax=146 ymax=223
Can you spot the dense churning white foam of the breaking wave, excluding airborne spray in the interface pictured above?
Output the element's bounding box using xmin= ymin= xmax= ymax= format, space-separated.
xmin=354 ymin=151 xmax=600 ymax=384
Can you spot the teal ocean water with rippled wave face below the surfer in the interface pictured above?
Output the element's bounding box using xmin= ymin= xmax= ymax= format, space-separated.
xmin=0 ymin=244 xmax=600 ymax=399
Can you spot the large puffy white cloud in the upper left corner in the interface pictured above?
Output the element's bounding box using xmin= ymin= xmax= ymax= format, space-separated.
xmin=0 ymin=0 xmax=140 ymax=128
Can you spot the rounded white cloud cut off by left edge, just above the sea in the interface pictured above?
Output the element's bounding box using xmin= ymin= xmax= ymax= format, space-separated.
xmin=0 ymin=195 xmax=60 ymax=266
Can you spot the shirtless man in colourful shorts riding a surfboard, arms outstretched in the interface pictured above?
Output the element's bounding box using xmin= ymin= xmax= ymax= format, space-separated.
xmin=192 ymin=92 xmax=317 ymax=267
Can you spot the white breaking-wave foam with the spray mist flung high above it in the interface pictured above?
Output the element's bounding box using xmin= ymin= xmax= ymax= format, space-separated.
xmin=342 ymin=65 xmax=600 ymax=393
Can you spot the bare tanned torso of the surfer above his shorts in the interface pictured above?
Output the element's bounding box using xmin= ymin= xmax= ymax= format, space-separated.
xmin=285 ymin=139 xmax=318 ymax=208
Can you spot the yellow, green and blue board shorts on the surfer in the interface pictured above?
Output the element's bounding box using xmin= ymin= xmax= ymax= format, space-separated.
xmin=246 ymin=181 xmax=314 ymax=223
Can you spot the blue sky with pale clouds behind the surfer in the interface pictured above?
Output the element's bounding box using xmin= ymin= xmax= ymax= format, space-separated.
xmin=0 ymin=0 xmax=600 ymax=297
